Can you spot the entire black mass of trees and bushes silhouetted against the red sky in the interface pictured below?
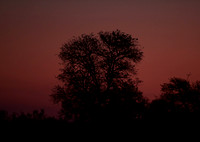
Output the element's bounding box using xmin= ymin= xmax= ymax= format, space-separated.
xmin=0 ymin=30 xmax=200 ymax=129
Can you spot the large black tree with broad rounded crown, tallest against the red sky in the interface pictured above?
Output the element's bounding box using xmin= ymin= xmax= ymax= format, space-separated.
xmin=51 ymin=30 xmax=145 ymax=121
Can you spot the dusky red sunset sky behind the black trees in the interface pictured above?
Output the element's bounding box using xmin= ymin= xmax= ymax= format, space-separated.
xmin=0 ymin=0 xmax=200 ymax=115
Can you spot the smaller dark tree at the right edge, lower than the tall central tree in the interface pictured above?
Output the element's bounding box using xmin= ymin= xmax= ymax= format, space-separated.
xmin=151 ymin=77 xmax=200 ymax=119
